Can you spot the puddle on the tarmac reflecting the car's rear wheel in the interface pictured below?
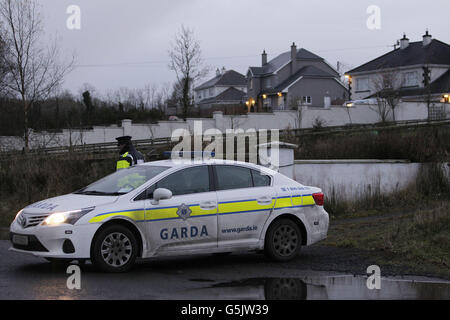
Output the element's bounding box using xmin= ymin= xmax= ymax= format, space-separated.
xmin=188 ymin=275 xmax=450 ymax=300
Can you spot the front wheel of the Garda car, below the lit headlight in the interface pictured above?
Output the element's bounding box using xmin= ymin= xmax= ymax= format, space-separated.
xmin=91 ymin=225 xmax=138 ymax=272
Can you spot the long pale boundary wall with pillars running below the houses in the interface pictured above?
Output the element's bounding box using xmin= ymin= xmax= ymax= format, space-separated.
xmin=0 ymin=102 xmax=450 ymax=151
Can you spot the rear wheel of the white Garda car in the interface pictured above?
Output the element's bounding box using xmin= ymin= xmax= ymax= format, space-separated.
xmin=264 ymin=219 xmax=302 ymax=261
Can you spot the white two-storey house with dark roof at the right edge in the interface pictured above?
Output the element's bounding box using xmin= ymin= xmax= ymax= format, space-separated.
xmin=346 ymin=31 xmax=450 ymax=101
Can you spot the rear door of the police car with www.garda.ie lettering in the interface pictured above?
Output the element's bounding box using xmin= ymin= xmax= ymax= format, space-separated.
xmin=214 ymin=165 xmax=276 ymax=247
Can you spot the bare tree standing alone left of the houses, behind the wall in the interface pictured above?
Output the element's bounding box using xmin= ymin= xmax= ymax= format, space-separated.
xmin=169 ymin=26 xmax=209 ymax=120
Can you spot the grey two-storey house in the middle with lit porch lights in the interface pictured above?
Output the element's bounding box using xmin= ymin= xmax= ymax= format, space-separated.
xmin=246 ymin=43 xmax=348 ymax=111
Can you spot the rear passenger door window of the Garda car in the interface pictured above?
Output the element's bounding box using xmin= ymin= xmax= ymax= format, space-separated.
xmin=216 ymin=166 xmax=253 ymax=190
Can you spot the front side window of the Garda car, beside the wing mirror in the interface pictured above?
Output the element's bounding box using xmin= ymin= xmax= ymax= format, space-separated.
xmin=156 ymin=166 xmax=210 ymax=196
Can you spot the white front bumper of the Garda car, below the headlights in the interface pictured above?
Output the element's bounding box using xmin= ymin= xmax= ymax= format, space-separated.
xmin=9 ymin=221 xmax=100 ymax=259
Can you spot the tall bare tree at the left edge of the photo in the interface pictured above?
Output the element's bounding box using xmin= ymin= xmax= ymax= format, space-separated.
xmin=0 ymin=0 xmax=74 ymax=152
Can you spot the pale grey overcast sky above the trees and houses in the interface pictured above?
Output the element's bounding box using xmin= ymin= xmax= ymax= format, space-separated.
xmin=39 ymin=0 xmax=450 ymax=93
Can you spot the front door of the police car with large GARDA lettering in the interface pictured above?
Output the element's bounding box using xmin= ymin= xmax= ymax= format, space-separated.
xmin=145 ymin=165 xmax=217 ymax=254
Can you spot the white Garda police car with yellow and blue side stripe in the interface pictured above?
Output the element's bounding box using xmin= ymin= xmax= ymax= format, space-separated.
xmin=10 ymin=160 xmax=329 ymax=272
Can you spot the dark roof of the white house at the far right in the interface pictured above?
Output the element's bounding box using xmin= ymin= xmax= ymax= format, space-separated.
xmin=347 ymin=39 xmax=450 ymax=74
